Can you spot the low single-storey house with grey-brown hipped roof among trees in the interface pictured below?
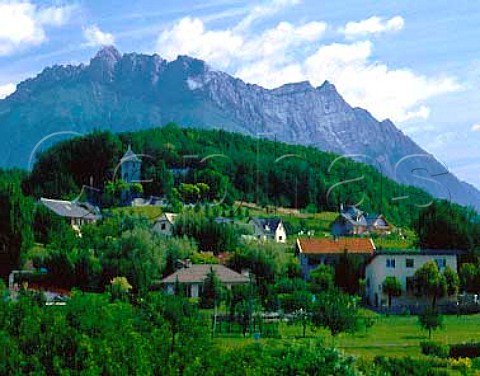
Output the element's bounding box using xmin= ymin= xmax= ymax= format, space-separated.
xmin=161 ymin=264 xmax=250 ymax=298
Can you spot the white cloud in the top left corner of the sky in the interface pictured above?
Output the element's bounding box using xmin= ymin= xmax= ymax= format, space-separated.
xmin=0 ymin=1 xmax=74 ymax=55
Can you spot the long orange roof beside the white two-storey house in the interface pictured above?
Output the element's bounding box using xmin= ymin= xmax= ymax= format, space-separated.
xmin=297 ymin=238 xmax=375 ymax=255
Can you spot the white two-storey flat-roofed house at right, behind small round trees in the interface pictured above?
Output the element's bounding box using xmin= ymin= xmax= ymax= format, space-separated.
xmin=365 ymin=250 xmax=458 ymax=307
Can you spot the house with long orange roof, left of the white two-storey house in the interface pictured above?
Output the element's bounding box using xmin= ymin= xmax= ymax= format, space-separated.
xmin=296 ymin=238 xmax=375 ymax=278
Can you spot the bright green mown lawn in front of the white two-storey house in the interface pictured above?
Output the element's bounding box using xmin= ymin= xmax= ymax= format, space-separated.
xmin=216 ymin=315 xmax=480 ymax=358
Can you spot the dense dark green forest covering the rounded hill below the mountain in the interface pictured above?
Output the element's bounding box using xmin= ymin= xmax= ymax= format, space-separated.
xmin=24 ymin=124 xmax=444 ymax=226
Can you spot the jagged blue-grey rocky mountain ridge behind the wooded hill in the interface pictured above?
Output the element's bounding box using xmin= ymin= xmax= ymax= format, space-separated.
xmin=0 ymin=47 xmax=480 ymax=209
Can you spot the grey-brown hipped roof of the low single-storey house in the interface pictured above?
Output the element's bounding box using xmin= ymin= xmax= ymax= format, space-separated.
xmin=161 ymin=264 xmax=250 ymax=283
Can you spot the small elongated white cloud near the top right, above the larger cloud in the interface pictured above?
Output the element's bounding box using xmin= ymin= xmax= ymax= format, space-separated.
xmin=341 ymin=16 xmax=405 ymax=39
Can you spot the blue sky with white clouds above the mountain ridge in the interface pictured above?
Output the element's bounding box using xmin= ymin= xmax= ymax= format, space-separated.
xmin=0 ymin=0 xmax=480 ymax=188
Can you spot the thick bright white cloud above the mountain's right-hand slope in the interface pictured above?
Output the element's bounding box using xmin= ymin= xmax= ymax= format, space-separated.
xmin=304 ymin=42 xmax=459 ymax=122
